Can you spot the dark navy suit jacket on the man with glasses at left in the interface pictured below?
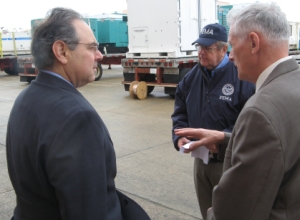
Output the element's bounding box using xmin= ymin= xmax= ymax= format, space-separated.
xmin=6 ymin=72 xmax=122 ymax=220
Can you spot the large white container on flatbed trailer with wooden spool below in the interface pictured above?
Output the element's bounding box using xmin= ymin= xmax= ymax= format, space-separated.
xmin=122 ymin=0 xmax=218 ymax=99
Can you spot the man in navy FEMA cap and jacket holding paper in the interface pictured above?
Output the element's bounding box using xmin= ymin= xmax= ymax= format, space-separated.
xmin=172 ymin=24 xmax=255 ymax=219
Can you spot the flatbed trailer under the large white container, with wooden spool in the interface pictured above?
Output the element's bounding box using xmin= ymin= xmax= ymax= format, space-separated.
xmin=122 ymin=56 xmax=199 ymax=99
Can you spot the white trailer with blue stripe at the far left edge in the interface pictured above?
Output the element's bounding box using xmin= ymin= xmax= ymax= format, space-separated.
xmin=0 ymin=30 xmax=31 ymax=75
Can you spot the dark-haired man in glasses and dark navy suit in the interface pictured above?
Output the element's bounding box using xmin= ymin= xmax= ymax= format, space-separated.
xmin=6 ymin=8 xmax=139 ymax=220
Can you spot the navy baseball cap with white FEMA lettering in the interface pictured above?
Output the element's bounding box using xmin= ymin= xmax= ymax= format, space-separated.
xmin=192 ymin=23 xmax=227 ymax=46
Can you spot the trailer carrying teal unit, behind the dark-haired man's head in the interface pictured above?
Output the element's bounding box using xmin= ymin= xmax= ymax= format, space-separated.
xmin=17 ymin=13 xmax=128 ymax=82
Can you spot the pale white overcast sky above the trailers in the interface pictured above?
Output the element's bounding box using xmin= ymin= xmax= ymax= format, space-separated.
xmin=0 ymin=0 xmax=300 ymax=29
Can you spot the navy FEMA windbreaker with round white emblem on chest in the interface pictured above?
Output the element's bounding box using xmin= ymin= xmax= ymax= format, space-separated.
xmin=171 ymin=61 xmax=255 ymax=160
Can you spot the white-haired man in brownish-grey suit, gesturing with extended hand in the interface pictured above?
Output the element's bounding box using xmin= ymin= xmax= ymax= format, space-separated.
xmin=176 ymin=3 xmax=300 ymax=220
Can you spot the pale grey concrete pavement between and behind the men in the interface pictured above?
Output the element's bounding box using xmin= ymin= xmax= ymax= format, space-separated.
xmin=0 ymin=65 xmax=202 ymax=220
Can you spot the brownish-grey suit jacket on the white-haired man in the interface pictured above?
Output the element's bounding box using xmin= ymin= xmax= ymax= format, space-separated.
xmin=207 ymin=59 xmax=300 ymax=220
